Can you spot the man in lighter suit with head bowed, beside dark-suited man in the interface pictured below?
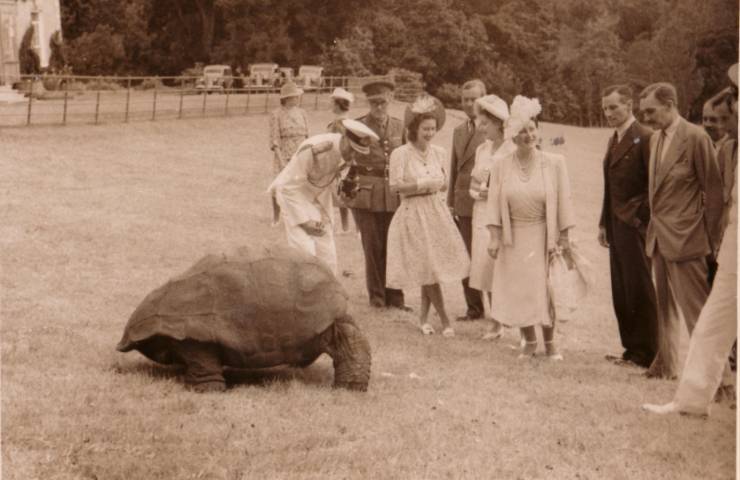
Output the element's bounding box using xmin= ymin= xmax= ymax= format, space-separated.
xmin=640 ymin=83 xmax=722 ymax=378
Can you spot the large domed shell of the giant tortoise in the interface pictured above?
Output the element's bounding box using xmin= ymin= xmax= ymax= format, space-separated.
xmin=116 ymin=246 xmax=347 ymax=368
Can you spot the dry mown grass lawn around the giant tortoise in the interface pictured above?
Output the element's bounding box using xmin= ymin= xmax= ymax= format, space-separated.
xmin=0 ymin=106 xmax=736 ymax=480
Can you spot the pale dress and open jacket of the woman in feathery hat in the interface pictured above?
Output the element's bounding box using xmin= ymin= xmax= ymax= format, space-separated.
xmin=487 ymin=152 xmax=574 ymax=327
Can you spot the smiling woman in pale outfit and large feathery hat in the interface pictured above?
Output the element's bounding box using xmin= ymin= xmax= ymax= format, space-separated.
xmin=487 ymin=96 xmax=574 ymax=360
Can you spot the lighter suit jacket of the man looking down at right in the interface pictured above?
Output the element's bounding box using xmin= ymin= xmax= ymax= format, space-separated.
xmin=645 ymin=118 xmax=723 ymax=262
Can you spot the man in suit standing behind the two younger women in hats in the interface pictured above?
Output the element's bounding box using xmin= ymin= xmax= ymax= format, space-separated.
xmin=447 ymin=80 xmax=486 ymax=321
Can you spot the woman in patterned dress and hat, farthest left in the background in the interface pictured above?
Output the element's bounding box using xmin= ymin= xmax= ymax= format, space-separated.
xmin=270 ymin=82 xmax=308 ymax=175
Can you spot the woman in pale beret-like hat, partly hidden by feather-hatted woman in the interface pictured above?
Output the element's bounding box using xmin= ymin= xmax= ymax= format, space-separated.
xmin=469 ymin=95 xmax=514 ymax=340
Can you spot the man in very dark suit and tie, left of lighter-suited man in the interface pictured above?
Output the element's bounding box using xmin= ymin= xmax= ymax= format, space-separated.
xmin=598 ymin=85 xmax=657 ymax=368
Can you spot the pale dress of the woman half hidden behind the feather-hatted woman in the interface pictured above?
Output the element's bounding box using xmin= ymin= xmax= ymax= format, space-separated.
xmin=469 ymin=140 xmax=515 ymax=292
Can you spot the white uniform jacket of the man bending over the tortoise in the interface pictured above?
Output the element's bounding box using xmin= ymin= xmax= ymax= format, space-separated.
xmin=268 ymin=133 xmax=344 ymax=226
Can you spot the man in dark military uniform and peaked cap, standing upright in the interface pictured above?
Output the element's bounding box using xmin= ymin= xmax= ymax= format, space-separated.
xmin=346 ymin=80 xmax=409 ymax=310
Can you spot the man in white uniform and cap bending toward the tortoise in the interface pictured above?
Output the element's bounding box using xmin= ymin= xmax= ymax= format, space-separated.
xmin=268 ymin=119 xmax=378 ymax=275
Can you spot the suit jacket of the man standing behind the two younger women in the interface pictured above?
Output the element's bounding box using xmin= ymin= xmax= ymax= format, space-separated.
xmin=447 ymin=121 xmax=486 ymax=217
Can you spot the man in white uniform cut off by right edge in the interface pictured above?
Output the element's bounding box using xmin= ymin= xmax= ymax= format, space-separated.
xmin=642 ymin=64 xmax=738 ymax=415
